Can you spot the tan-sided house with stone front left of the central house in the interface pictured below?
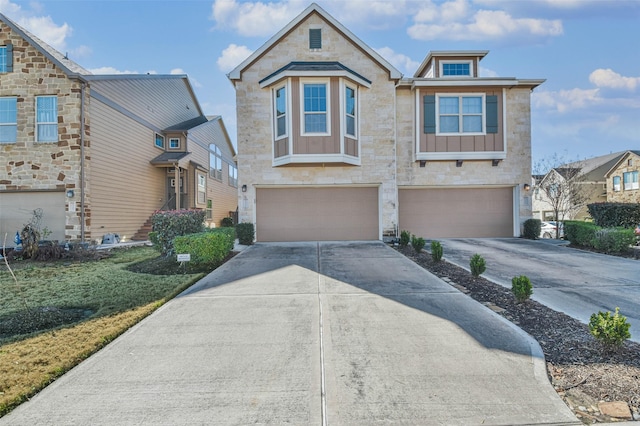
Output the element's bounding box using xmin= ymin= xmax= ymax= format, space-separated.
xmin=0 ymin=15 xmax=238 ymax=242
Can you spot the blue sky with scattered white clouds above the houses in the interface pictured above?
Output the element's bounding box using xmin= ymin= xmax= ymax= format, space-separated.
xmin=0 ymin=0 xmax=640 ymax=167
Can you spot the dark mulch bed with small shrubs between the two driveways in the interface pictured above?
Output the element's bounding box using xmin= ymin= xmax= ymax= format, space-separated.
xmin=396 ymin=246 xmax=640 ymax=424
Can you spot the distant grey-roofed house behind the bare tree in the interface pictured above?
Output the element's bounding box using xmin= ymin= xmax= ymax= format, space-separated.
xmin=533 ymin=151 xmax=624 ymax=221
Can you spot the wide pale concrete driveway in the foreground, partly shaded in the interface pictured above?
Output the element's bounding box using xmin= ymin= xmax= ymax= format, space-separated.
xmin=0 ymin=243 xmax=580 ymax=425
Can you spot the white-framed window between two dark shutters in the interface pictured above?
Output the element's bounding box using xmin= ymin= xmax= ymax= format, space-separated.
xmin=437 ymin=96 xmax=484 ymax=134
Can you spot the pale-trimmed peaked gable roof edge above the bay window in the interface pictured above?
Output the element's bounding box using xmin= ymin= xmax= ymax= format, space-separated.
xmin=227 ymin=3 xmax=402 ymax=81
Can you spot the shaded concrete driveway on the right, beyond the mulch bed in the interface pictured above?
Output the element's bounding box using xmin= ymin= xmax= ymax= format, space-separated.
xmin=441 ymin=238 xmax=640 ymax=342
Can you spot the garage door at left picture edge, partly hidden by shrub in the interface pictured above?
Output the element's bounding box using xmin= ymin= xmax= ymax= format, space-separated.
xmin=0 ymin=192 xmax=65 ymax=246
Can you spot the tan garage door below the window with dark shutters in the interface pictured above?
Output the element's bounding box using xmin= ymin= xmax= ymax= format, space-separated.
xmin=398 ymin=188 xmax=513 ymax=238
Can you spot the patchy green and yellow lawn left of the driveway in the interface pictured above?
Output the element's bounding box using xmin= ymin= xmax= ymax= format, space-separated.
xmin=0 ymin=247 xmax=206 ymax=416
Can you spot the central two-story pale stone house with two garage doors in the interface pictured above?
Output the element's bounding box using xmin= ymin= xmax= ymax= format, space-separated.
xmin=228 ymin=4 xmax=544 ymax=241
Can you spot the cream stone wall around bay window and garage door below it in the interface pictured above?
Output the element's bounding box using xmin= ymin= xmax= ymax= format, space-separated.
xmin=236 ymin=14 xmax=397 ymax=238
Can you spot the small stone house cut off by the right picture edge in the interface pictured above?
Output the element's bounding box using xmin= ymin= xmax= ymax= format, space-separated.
xmin=605 ymin=150 xmax=640 ymax=203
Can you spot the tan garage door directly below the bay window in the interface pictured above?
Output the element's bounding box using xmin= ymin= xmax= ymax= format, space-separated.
xmin=256 ymin=187 xmax=379 ymax=241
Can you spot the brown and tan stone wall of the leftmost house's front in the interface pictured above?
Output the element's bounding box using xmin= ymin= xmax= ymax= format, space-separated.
xmin=0 ymin=23 xmax=90 ymax=240
